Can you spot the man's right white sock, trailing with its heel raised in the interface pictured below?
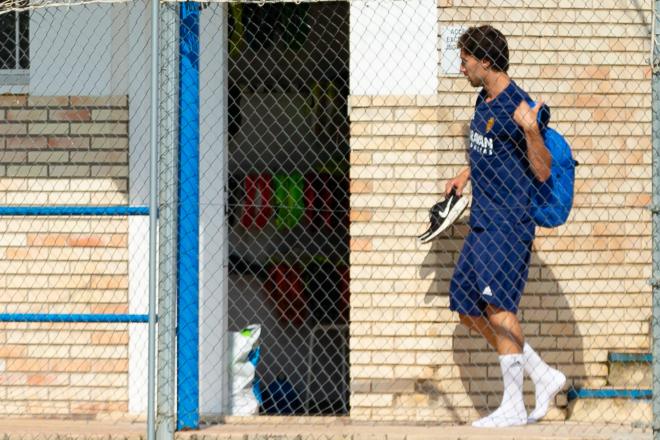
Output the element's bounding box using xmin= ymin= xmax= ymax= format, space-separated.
xmin=523 ymin=342 xmax=566 ymax=423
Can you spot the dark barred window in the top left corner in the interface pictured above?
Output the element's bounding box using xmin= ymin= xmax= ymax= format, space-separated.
xmin=0 ymin=0 xmax=30 ymax=72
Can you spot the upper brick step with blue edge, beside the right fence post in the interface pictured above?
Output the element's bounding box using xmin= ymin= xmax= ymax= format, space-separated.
xmin=607 ymin=353 xmax=653 ymax=389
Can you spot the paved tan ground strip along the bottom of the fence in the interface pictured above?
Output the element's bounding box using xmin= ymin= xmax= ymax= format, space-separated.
xmin=0 ymin=418 xmax=652 ymax=440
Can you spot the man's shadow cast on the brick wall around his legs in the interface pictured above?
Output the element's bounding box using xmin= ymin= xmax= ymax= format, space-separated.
xmin=415 ymin=220 xmax=587 ymax=423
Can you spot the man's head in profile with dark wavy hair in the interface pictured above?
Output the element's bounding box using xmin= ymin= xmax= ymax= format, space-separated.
xmin=458 ymin=25 xmax=509 ymax=87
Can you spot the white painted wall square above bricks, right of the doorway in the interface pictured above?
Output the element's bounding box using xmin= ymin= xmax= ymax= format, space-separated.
xmin=350 ymin=0 xmax=439 ymax=95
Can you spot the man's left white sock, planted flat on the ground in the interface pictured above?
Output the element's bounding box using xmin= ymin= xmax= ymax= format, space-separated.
xmin=472 ymin=354 xmax=527 ymax=428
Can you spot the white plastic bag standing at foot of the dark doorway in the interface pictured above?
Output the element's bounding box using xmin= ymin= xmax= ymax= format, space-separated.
xmin=229 ymin=324 xmax=261 ymax=416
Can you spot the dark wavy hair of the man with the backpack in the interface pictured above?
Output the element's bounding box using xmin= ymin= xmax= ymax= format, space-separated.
xmin=458 ymin=25 xmax=509 ymax=72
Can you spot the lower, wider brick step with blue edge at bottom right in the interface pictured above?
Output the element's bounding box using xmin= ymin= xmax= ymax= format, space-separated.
xmin=567 ymin=387 xmax=653 ymax=426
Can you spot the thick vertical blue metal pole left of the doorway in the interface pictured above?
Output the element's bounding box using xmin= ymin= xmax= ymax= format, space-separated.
xmin=177 ymin=2 xmax=199 ymax=430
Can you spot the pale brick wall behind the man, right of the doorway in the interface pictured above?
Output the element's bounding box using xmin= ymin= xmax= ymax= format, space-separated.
xmin=350 ymin=0 xmax=651 ymax=422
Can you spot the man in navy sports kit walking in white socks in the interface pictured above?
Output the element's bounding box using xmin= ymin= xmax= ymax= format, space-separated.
xmin=445 ymin=26 xmax=566 ymax=427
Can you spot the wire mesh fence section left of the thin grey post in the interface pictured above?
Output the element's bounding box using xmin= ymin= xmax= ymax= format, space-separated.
xmin=0 ymin=2 xmax=149 ymax=437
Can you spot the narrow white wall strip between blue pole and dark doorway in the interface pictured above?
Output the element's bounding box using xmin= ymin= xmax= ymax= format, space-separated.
xmin=199 ymin=3 xmax=228 ymax=416
